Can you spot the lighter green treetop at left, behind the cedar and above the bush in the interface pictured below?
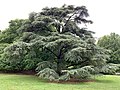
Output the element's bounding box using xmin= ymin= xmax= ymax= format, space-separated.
xmin=0 ymin=19 xmax=25 ymax=43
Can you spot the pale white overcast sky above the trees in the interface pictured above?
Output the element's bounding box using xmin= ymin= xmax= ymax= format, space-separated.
xmin=0 ymin=0 xmax=120 ymax=37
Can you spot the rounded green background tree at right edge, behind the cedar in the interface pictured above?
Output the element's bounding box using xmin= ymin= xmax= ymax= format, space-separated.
xmin=97 ymin=33 xmax=120 ymax=64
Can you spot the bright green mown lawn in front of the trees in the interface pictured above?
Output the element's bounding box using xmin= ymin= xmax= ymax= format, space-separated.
xmin=0 ymin=74 xmax=120 ymax=90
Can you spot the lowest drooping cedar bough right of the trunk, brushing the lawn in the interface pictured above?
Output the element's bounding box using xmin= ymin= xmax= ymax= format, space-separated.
xmin=59 ymin=66 xmax=94 ymax=80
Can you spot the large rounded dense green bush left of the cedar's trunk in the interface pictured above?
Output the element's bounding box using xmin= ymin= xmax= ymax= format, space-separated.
xmin=0 ymin=42 xmax=40 ymax=72
